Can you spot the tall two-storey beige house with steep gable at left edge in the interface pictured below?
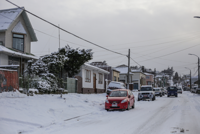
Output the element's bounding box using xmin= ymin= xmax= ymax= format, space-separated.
xmin=0 ymin=8 xmax=38 ymax=75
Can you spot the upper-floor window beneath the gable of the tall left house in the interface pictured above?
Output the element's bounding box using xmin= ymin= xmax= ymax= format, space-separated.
xmin=13 ymin=34 xmax=24 ymax=52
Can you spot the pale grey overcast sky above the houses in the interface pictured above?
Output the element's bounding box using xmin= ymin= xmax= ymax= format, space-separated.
xmin=0 ymin=0 xmax=200 ymax=75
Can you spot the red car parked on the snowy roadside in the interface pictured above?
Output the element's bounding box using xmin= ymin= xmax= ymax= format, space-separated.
xmin=105 ymin=89 xmax=135 ymax=111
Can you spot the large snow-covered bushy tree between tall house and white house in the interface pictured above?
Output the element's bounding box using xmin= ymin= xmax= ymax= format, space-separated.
xmin=25 ymin=46 xmax=93 ymax=91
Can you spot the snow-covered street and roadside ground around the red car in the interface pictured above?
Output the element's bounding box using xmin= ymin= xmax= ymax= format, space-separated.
xmin=0 ymin=91 xmax=200 ymax=134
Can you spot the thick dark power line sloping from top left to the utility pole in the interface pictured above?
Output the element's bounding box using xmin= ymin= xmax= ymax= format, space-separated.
xmin=6 ymin=0 xmax=126 ymax=56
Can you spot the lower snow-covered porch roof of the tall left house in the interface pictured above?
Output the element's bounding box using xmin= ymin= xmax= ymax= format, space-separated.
xmin=0 ymin=45 xmax=38 ymax=59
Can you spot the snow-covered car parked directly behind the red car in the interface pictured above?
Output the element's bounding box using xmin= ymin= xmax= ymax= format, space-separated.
xmin=106 ymin=81 xmax=126 ymax=95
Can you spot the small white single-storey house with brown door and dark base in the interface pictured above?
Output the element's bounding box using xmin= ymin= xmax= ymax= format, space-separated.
xmin=75 ymin=63 xmax=109 ymax=93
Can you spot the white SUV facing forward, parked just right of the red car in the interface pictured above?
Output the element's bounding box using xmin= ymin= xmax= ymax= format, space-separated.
xmin=138 ymin=85 xmax=156 ymax=101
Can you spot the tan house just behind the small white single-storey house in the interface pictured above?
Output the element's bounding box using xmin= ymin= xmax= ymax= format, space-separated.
xmin=90 ymin=61 xmax=120 ymax=81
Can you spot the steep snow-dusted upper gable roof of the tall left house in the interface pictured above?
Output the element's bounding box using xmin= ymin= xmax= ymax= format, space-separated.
xmin=0 ymin=7 xmax=37 ymax=41
